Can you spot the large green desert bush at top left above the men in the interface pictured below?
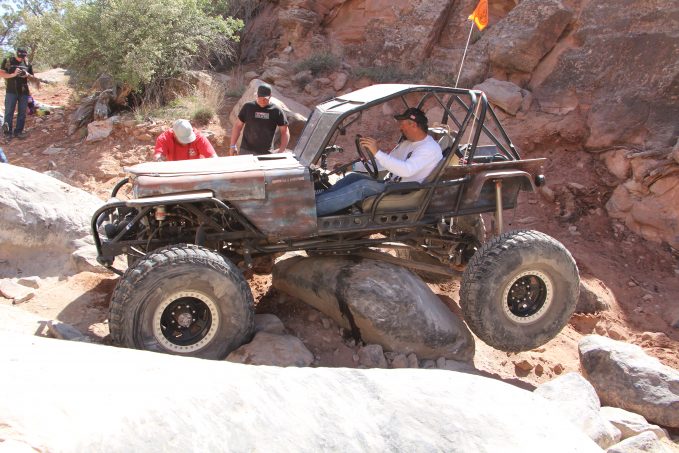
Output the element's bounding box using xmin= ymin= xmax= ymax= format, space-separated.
xmin=20 ymin=0 xmax=243 ymax=89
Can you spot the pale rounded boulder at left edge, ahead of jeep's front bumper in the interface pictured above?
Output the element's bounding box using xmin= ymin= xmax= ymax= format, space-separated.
xmin=0 ymin=165 xmax=102 ymax=277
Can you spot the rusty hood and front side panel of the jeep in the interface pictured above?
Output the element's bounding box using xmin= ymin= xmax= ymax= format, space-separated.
xmin=126 ymin=153 xmax=316 ymax=239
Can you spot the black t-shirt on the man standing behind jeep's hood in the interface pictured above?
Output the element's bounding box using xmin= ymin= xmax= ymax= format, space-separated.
xmin=238 ymin=101 xmax=288 ymax=154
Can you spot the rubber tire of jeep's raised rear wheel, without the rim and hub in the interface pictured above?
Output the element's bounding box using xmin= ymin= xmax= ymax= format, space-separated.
xmin=460 ymin=230 xmax=580 ymax=352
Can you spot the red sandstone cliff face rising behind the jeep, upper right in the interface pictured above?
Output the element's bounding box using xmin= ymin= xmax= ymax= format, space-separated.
xmin=242 ymin=0 xmax=679 ymax=248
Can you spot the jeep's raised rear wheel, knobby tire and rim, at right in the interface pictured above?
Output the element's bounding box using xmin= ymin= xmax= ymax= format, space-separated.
xmin=460 ymin=230 xmax=580 ymax=352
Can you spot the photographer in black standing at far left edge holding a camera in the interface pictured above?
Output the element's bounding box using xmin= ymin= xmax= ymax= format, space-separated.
xmin=0 ymin=48 xmax=33 ymax=140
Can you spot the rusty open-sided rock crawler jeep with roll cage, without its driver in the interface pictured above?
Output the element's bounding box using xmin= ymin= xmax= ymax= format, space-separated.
xmin=92 ymin=84 xmax=579 ymax=358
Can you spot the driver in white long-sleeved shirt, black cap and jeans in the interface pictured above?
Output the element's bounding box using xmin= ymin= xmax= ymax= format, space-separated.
xmin=316 ymin=107 xmax=442 ymax=216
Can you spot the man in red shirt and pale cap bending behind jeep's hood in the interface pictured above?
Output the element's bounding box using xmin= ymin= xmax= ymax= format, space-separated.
xmin=153 ymin=120 xmax=217 ymax=161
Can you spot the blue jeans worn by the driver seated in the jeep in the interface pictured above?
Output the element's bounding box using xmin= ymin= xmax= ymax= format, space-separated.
xmin=316 ymin=173 xmax=385 ymax=217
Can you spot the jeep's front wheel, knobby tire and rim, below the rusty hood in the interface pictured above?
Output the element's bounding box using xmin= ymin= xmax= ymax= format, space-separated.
xmin=109 ymin=244 xmax=254 ymax=359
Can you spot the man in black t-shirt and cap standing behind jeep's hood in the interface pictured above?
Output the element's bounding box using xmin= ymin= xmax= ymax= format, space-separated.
xmin=228 ymin=83 xmax=290 ymax=156
